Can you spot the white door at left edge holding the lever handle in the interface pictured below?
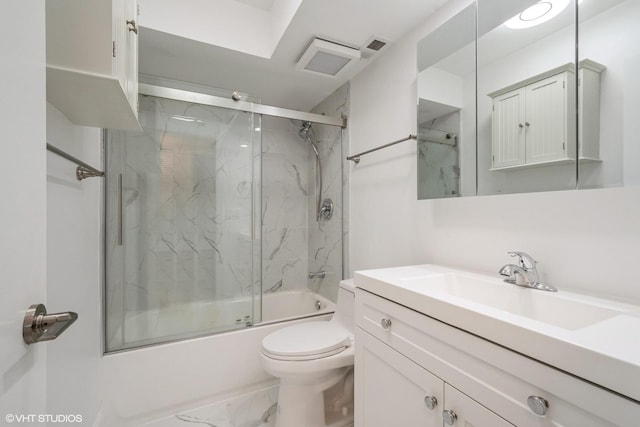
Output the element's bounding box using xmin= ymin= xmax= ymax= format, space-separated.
xmin=0 ymin=0 xmax=46 ymax=418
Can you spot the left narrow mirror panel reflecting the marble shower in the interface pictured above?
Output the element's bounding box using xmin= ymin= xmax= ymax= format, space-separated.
xmin=417 ymin=4 xmax=476 ymax=199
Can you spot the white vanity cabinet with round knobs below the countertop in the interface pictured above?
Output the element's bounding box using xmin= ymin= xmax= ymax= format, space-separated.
xmin=355 ymin=289 xmax=640 ymax=427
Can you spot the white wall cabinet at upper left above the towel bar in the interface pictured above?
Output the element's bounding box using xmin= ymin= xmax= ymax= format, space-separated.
xmin=46 ymin=0 xmax=140 ymax=130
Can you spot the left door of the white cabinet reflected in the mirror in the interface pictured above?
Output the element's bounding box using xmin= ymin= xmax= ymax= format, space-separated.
xmin=491 ymin=89 xmax=525 ymax=168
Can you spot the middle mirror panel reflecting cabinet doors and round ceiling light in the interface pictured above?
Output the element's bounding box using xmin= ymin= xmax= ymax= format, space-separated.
xmin=477 ymin=0 xmax=576 ymax=195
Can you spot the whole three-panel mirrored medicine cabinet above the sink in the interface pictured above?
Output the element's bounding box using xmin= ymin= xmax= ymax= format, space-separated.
xmin=417 ymin=0 xmax=640 ymax=199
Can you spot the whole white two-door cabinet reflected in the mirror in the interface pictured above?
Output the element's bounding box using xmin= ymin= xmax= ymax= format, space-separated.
xmin=489 ymin=60 xmax=603 ymax=171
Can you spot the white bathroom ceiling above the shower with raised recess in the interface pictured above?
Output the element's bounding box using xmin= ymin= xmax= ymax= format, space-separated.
xmin=139 ymin=0 xmax=447 ymax=111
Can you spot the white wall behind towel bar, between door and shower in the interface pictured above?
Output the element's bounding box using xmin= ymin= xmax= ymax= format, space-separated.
xmin=41 ymin=104 xmax=103 ymax=425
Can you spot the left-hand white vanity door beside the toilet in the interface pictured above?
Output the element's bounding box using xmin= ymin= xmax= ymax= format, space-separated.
xmin=355 ymin=328 xmax=444 ymax=427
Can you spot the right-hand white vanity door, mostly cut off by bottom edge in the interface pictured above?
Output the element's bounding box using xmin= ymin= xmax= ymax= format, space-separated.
xmin=444 ymin=384 xmax=514 ymax=427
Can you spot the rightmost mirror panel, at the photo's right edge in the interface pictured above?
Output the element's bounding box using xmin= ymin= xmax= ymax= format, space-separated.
xmin=578 ymin=0 xmax=640 ymax=188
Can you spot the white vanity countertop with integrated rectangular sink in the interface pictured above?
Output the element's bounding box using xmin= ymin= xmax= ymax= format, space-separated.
xmin=354 ymin=265 xmax=640 ymax=402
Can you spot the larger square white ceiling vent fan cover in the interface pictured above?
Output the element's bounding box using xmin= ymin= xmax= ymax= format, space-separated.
xmin=296 ymin=39 xmax=360 ymax=77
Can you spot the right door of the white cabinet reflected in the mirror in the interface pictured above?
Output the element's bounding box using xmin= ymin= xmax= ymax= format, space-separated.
xmin=525 ymin=73 xmax=567 ymax=163
